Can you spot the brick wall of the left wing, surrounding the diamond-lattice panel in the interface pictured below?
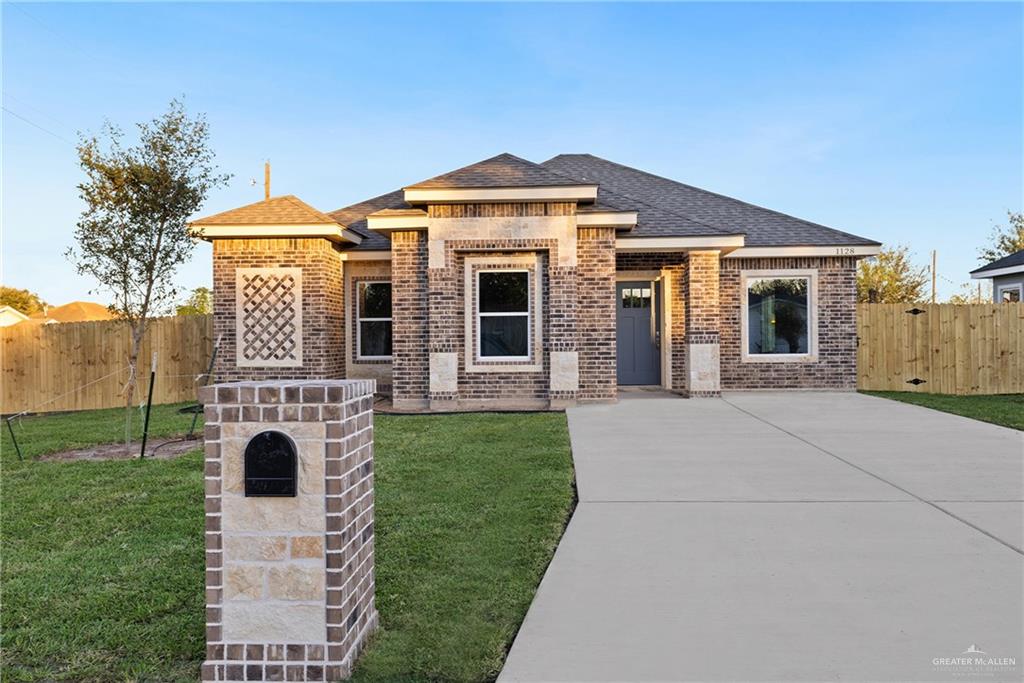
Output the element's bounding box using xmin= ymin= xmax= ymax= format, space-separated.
xmin=213 ymin=239 xmax=345 ymax=382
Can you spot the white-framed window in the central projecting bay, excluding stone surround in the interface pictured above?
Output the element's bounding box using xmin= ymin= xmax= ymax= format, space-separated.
xmin=476 ymin=270 xmax=530 ymax=360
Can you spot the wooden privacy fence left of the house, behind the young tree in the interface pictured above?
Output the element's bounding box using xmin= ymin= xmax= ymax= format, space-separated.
xmin=0 ymin=315 xmax=213 ymax=415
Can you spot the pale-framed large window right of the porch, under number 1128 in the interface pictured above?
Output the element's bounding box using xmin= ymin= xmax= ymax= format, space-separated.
xmin=740 ymin=270 xmax=818 ymax=362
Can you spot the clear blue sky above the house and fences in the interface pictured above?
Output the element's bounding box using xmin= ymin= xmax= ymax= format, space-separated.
xmin=2 ymin=3 xmax=1024 ymax=303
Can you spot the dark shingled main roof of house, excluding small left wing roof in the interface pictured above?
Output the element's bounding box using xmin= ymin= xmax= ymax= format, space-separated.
xmin=328 ymin=154 xmax=879 ymax=251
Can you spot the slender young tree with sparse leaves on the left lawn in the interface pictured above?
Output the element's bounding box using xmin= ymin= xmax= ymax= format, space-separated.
xmin=68 ymin=99 xmax=229 ymax=440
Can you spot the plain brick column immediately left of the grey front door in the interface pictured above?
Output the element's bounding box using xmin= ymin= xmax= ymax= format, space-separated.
xmin=575 ymin=227 xmax=616 ymax=402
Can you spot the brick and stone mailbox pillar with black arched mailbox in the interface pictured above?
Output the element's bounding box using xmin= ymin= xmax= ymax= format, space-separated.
xmin=201 ymin=380 xmax=377 ymax=681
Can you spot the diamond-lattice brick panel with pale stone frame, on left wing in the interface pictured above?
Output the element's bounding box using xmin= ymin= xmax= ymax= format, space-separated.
xmin=234 ymin=268 xmax=302 ymax=367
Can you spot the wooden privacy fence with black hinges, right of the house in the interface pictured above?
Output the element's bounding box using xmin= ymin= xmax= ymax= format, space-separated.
xmin=857 ymin=303 xmax=1024 ymax=394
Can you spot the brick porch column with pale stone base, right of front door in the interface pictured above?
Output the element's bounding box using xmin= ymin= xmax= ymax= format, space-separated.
xmin=686 ymin=250 xmax=722 ymax=397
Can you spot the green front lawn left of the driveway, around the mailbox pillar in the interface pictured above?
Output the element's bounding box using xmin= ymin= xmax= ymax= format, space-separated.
xmin=0 ymin=407 xmax=572 ymax=681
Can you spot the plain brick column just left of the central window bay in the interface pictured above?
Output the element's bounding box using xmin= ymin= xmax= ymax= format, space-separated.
xmin=391 ymin=230 xmax=430 ymax=410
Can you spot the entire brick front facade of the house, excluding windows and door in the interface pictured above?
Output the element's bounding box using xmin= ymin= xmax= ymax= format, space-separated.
xmin=214 ymin=227 xmax=856 ymax=410
